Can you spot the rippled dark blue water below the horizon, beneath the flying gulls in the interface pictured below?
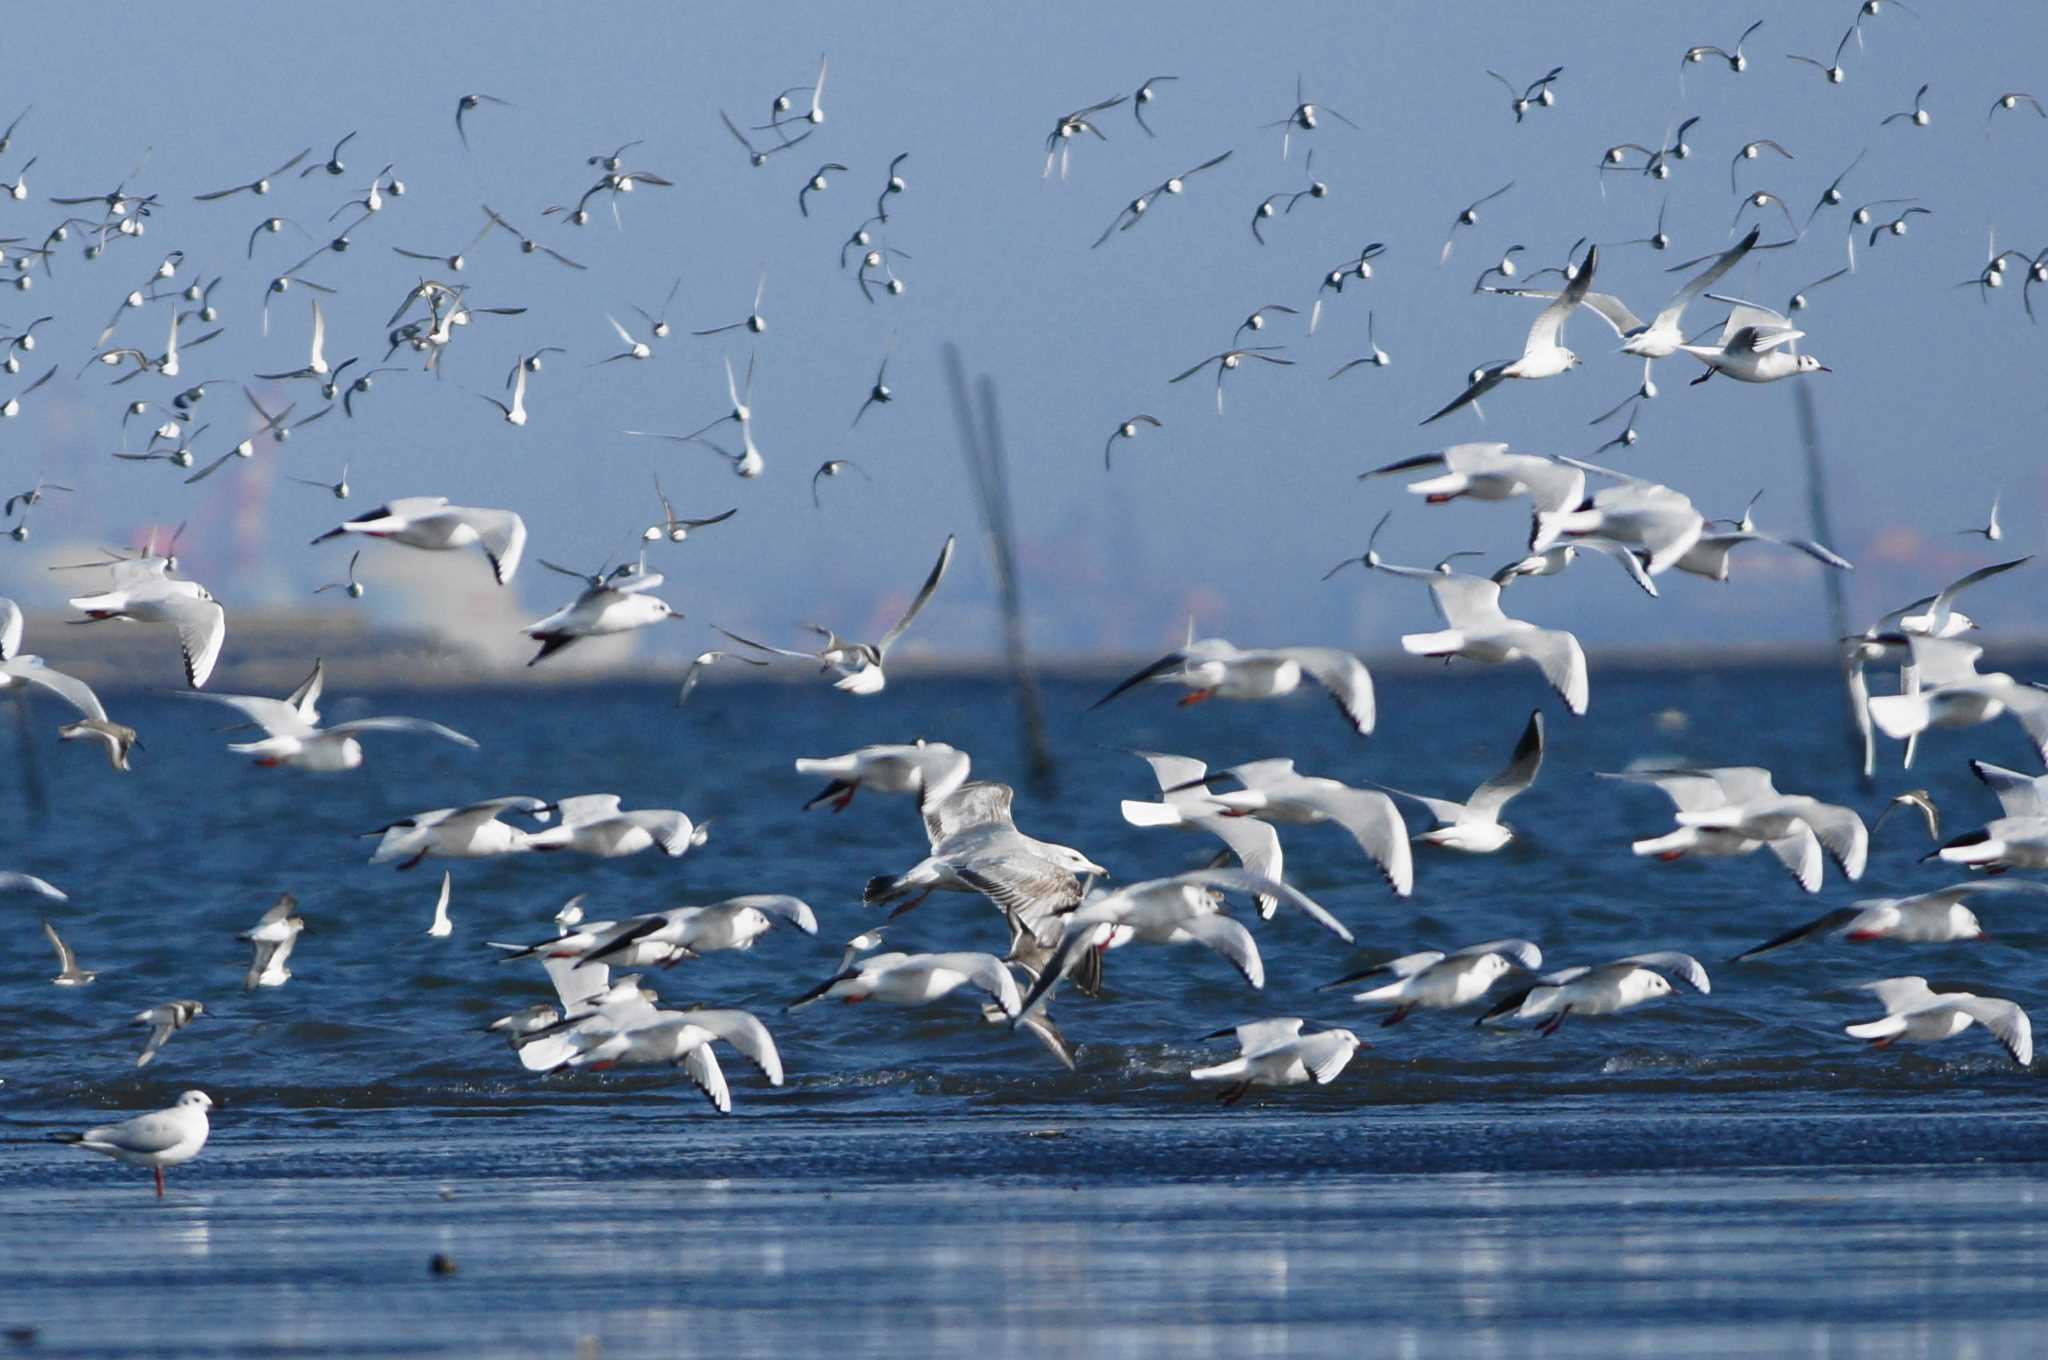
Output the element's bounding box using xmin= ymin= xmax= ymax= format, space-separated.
xmin=0 ymin=675 xmax=2048 ymax=1356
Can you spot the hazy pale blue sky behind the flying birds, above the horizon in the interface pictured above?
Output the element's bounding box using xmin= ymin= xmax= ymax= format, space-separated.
xmin=0 ymin=2 xmax=2048 ymax=653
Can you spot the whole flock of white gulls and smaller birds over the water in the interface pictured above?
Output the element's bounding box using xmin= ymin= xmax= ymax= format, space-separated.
xmin=0 ymin=0 xmax=2048 ymax=1194
